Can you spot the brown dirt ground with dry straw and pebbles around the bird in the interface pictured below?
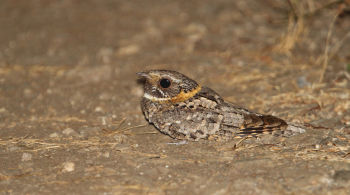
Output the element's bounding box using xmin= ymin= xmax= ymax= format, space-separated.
xmin=0 ymin=0 xmax=350 ymax=194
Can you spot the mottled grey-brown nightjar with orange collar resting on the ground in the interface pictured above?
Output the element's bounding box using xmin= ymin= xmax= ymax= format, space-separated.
xmin=137 ymin=70 xmax=305 ymax=141
